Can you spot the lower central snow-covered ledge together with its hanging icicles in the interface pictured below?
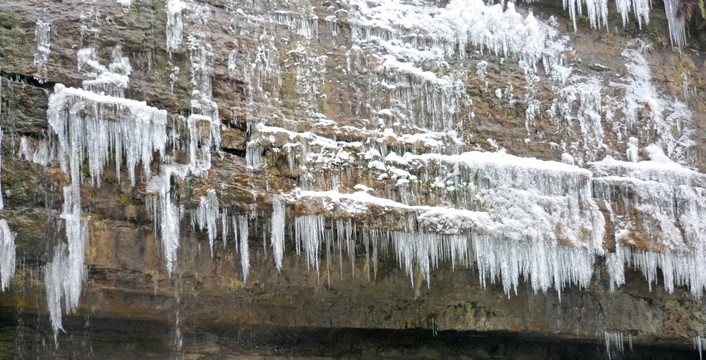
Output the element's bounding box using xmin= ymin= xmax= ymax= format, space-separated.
xmin=295 ymin=187 xmax=602 ymax=296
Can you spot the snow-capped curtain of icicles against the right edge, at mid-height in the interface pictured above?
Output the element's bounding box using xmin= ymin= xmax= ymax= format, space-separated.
xmin=592 ymin=144 xmax=706 ymax=297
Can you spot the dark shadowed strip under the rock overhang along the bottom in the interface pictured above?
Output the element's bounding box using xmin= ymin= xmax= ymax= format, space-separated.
xmin=0 ymin=309 xmax=699 ymax=360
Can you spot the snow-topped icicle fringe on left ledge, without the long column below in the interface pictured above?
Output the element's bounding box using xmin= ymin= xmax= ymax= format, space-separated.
xmin=47 ymin=84 xmax=167 ymax=185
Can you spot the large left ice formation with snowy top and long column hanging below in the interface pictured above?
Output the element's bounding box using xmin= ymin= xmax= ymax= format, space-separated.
xmin=45 ymin=50 xmax=167 ymax=336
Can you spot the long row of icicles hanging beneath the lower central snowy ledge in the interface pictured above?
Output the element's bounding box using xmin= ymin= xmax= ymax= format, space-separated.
xmin=284 ymin=215 xmax=595 ymax=296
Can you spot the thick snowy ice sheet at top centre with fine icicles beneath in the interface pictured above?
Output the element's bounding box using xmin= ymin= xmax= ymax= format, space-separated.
xmin=346 ymin=0 xmax=571 ymax=131
